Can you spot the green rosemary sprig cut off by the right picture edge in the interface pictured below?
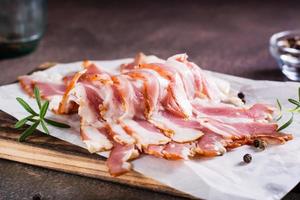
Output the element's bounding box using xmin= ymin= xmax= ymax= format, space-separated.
xmin=276 ymin=87 xmax=300 ymax=132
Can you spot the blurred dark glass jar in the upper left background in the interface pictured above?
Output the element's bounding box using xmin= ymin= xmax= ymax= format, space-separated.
xmin=0 ymin=0 xmax=47 ymax=58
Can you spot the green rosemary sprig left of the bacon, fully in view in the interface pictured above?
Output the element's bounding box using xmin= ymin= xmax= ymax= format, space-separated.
xmin=15 ymin=87 xmax=70 ymax=142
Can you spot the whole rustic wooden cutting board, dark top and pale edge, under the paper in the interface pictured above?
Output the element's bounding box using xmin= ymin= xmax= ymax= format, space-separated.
xmin=0 ymin=111 xmax=193 ymax=198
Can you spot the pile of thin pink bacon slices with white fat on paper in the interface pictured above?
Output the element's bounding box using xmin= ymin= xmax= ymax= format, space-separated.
xmin=19 ymin=54 xmax=292 ymax=176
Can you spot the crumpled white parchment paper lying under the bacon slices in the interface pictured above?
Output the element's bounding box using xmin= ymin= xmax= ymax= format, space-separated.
xmin=0 ymin=59 xmax=300 ymax=200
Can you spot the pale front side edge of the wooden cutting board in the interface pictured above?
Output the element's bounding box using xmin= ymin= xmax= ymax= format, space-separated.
xmin=0 ymin=138 xmax=195 ymax=199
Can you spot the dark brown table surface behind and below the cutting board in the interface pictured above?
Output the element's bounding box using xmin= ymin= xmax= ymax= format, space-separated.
xmin=0 ymin=0 xmax=300 ymax=200
